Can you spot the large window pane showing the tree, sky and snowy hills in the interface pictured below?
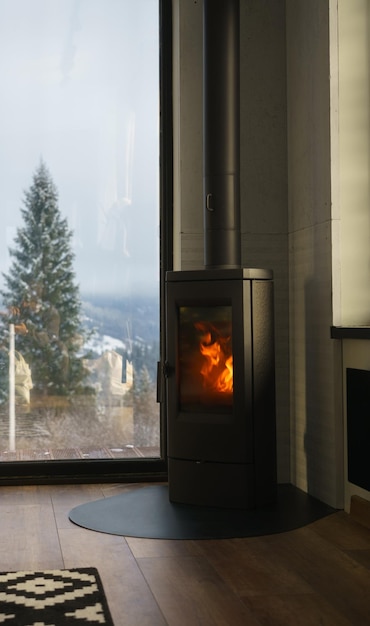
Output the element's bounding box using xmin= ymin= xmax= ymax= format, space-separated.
xmin=0 ymin=0 xmax=159 ymax=461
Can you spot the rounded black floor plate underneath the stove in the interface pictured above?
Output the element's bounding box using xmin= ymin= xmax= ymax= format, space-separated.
xmin=69 ymin=485 xmax=335 ymax=539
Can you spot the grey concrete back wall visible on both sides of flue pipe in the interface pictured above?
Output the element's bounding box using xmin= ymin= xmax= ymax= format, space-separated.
xmin=174 ymin=0 xmax=290 ymax=482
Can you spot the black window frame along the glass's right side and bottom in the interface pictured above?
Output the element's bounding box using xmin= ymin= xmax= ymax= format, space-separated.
xmin=0 ymin=0 xmax=173 ymax=485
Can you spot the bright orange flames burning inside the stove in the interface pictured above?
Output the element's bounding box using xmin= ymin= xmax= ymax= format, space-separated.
xmin=195 ymin=322 xmax=233 ymax=393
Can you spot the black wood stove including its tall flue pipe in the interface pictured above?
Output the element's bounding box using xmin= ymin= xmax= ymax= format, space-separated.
xmin=165 ymin=0 xmax=276 ymax=509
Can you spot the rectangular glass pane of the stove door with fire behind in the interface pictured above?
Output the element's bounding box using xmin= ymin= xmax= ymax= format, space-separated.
xmin=178 ymin=306 xmax=233 ymax=411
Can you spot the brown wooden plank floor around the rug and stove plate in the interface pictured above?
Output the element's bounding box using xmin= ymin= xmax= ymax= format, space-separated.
xmin=0 ymin=485 xmax=370 ymax=626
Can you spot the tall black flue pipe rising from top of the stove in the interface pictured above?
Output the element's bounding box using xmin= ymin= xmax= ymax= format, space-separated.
xmin=203 ymin=0 xmax=241 ymax=269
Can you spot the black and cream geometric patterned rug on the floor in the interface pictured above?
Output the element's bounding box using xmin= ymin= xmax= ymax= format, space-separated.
xmin=0 ymin=567 xmax=113 ymax=626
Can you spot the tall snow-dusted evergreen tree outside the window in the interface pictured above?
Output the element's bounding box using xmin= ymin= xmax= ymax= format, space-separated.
xmin=0 ymin=162 xmax=85 ymax=395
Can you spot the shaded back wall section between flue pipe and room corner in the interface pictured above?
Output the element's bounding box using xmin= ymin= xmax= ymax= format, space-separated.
xmin=240 ymin=0 xmax=290 ymax=482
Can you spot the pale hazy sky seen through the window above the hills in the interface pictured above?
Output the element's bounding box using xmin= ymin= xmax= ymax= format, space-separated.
xmin=0 ymin=0 xmax=159 ymax=295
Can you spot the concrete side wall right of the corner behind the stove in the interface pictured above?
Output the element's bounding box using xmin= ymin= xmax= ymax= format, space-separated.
xmin=286 ymin=0 xmax=343 ymax=506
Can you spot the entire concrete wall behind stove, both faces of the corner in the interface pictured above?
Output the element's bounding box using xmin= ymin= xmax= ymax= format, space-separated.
xmin=173 ymin=0 xmax=343 ymax=506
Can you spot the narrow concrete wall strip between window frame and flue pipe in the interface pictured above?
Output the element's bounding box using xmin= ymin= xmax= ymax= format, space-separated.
xmin=172 ymin=0 xmax=204 ymax=270
